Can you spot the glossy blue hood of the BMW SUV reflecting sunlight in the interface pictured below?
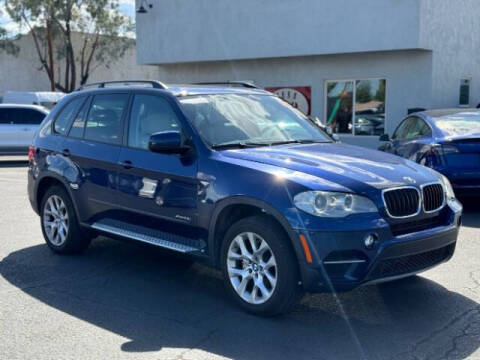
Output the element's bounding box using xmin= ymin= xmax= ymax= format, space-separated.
xmin=222 ymin=143 xmax=438 ymax=192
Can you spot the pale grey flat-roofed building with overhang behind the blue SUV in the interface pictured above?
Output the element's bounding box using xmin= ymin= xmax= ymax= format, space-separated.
xmin=133 ymin=0 xmax=480 ymax=146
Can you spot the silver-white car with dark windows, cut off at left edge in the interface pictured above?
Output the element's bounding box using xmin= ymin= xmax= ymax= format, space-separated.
xmin=0 ymin=104 xmax=49 ymax=155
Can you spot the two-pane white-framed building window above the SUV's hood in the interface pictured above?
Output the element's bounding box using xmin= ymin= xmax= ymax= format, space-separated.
xmin=326 ymin=79 xmax=386 ymax=136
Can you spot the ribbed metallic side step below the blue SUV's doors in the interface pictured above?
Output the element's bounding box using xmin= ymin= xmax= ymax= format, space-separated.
xmin=91 ymin=220 xmax=204 ymax=253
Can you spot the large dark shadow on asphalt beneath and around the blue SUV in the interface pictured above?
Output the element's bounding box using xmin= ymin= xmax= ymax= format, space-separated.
xmin=0 ymin=238 xmax=480 ymax=359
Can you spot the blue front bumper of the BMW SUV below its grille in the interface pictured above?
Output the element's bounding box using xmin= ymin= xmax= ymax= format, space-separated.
xmin=297 ymin=201 xmax=462 ymax=292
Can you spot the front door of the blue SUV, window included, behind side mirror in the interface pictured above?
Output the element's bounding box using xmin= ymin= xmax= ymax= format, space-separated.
xmin=118 ymin=93 xmax=198 ymax=233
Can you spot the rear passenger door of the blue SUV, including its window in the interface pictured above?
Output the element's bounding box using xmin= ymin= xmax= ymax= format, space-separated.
xmin=62 ymin=92 xmax=130 ymax=223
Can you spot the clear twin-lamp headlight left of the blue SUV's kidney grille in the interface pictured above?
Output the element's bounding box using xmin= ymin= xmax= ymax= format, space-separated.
xmin=293 ymin=191 xmax=378 ymax=218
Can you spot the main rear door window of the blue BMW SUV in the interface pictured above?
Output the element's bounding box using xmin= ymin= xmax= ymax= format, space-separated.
xmin=85 ymin=94 xmax=129 ymax=145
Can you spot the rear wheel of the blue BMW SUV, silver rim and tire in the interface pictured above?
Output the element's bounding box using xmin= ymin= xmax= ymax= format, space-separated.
xmin=40 ymin=185 xmax=92 ymax=254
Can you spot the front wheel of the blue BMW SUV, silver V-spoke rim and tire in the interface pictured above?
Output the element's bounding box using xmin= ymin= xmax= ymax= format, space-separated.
xmin=220 ymin=216 xmax=302 ymax=316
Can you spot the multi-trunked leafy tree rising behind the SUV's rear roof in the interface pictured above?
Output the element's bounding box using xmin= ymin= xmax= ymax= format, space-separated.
xmin=0 ymin=0 xmax=133 ymax=92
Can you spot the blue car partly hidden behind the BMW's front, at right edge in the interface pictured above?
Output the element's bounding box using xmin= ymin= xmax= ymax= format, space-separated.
xmin=379 ymin=109 xmax=480 ymax=196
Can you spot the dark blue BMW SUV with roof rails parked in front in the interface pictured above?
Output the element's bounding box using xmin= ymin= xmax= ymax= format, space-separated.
xmin=28 ymin=81 xmax=462 ymax=315
